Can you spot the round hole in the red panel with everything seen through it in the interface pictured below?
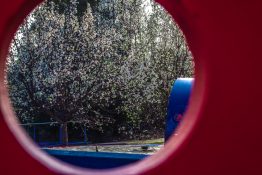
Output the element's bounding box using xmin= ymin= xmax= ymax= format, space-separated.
xmin=6 ymin=0 xmax=194 ymax=169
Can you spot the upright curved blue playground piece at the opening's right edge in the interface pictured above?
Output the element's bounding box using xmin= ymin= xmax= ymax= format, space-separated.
xmin=165 ymin=78 xmax=194 ymax=142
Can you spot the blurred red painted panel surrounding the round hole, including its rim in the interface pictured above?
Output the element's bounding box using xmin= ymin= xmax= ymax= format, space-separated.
xmin=0 ymin=0 xmax=262 ymax=175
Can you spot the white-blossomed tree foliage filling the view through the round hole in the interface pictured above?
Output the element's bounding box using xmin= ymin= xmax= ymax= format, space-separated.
xmin=6 ymin=0 xmax=193 ymax=144
